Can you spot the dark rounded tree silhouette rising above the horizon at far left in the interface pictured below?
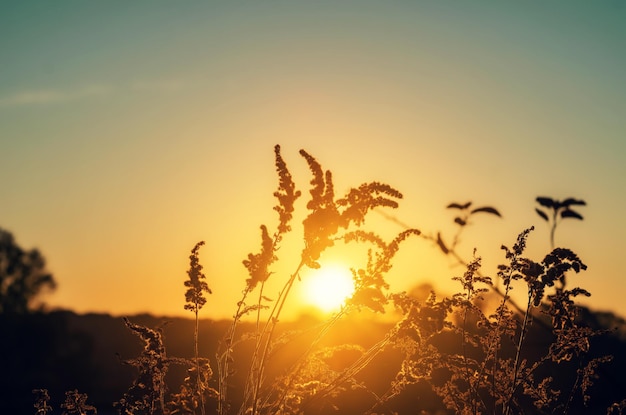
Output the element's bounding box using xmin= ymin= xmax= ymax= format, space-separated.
xmin=0 ymin=228 xmax=56 ymax=314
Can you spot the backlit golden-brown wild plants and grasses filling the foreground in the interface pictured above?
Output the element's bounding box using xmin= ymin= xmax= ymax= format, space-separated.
xmin=3 ymin=146 xmax=626 ymax=415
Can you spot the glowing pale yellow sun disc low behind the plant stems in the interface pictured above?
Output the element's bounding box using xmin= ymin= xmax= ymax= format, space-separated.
xmin=302 ymin=264 xmax=354 ymax=313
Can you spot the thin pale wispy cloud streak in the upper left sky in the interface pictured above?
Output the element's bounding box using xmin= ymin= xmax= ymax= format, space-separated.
xmin=0 ymin=79 xmax=184 ymax=108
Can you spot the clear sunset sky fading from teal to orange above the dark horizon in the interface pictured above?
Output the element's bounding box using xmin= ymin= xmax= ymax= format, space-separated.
xmin=0 ymin=0 xmax=626 ymax=318
